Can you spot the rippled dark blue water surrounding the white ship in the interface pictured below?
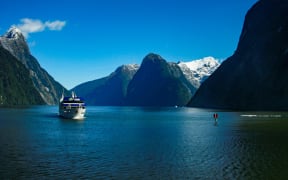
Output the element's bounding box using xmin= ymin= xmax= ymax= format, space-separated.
xmin=0 ymin=106 xmax=288 ymax=179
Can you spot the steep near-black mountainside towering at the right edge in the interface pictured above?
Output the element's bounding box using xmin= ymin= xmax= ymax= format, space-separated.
xmin=188 ymin=0 xmax=288 ymax=110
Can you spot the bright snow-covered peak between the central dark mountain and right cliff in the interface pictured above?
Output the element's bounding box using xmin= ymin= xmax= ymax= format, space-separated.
xmin=178 ymin=56 xmax=220 ymax=88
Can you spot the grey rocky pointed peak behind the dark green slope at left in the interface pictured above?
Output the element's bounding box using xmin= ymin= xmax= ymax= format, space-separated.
xmin=0 ymin=27 xmax=67 ymax=104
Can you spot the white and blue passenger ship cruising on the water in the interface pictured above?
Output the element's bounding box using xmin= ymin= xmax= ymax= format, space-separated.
xmin=59 ymin=92 xmax=86 ymax=119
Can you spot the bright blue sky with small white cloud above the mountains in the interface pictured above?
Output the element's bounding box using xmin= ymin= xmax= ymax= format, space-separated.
xmin=0 ymin=0 xmax=257 ymax=89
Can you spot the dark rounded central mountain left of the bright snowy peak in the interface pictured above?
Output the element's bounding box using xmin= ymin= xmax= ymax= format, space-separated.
xmin=126 ymin=53 xmax=196 ymax=106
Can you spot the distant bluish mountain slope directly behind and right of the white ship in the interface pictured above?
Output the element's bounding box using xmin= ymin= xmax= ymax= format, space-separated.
xmin=72 ymin=64 xmax=139 ymax=106
